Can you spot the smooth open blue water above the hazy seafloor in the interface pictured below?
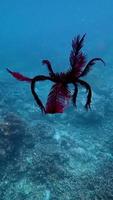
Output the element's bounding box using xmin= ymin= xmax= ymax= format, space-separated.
xmin=0 ymin=0 xmax=113 ymax=71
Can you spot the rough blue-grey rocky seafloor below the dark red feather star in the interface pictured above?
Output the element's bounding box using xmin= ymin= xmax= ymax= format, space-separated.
xmin=0 ymin=63 xmax=113 ymax=200
